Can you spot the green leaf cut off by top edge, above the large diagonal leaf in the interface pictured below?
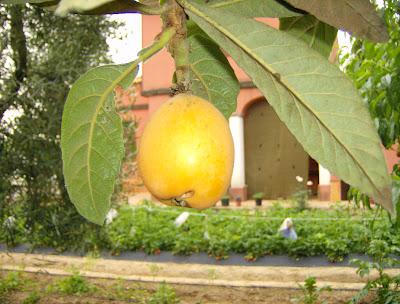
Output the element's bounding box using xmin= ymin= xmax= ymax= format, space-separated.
xmin=205 ymin=0 xmax=302 ymax=18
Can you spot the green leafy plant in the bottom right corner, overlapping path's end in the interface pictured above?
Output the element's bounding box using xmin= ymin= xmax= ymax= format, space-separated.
xmin=350 ymin=240 xmax=400 ymax=304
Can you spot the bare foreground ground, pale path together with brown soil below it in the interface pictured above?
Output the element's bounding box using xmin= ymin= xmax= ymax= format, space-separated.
xmin=0 ymin=253 xmax=386 ymax=304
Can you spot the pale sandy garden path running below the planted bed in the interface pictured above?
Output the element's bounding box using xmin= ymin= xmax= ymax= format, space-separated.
xmin=0 ymin=252 xmax=400 ymax=290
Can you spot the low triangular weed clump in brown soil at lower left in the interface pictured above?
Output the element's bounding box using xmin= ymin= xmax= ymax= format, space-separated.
xmin=49 ymin=272 xmax=97 ymax=295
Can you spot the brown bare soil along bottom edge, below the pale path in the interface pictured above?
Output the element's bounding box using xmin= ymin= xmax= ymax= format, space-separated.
xmin=3 ymin=274 xmax=360 ymax=304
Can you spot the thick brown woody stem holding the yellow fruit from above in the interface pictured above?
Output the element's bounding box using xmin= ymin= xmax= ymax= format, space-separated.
xmin=161 ymin=0 xmax=190 ymax=95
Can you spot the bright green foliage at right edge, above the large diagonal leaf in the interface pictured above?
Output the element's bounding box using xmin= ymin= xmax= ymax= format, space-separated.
xmin=340 ymin=0 xmax=400 ymax=148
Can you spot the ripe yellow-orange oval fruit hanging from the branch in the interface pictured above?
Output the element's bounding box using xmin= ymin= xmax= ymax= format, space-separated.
xmin=138 ymin=94 xmax=234 ymax=209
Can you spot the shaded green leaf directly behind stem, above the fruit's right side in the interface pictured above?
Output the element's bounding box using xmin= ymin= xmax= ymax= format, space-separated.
xmin=188 ymin=22 xmax=240 ymax=118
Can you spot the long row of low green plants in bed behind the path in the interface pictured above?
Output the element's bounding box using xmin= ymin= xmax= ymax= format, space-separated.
xmin=0 ymin=201 xmax=400 ymax=262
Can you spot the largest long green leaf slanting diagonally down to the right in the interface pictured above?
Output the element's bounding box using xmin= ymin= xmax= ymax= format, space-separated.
xmin=179 ymin=0 xmax=394 ymax=212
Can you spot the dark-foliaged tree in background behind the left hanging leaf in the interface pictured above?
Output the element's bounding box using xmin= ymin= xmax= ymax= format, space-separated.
xmin=0 ymin=5 xmax=118 ymax=240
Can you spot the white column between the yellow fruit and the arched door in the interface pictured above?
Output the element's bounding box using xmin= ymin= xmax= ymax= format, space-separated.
xmin=229 ymin=114 xmax=246 ymax=188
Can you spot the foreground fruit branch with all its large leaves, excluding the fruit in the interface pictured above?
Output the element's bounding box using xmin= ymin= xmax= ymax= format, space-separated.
xmin=0 ymin=0 xmax=395 ymax=225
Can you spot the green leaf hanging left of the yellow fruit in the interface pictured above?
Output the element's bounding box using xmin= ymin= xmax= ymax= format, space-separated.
xmin=61 ymin=64 xmax=137 ymax=225
